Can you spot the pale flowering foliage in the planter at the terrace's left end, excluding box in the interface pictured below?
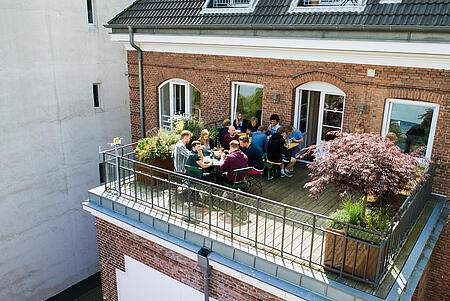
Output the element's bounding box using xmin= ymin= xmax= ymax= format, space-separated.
xmin=135 ymin=130 xmax=180 ymax=162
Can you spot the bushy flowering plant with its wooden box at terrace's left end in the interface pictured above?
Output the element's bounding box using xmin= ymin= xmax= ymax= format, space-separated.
xmin=135 ymin=130 xmax=180 ymax=181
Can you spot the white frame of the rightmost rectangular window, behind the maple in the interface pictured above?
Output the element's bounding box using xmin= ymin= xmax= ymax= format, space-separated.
xmin=381 ymin=98 xmax=439 ymax=159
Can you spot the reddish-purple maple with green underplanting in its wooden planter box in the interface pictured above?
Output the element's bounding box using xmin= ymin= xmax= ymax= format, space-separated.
xmin=305 ymin=133 xmax=417 ymax=281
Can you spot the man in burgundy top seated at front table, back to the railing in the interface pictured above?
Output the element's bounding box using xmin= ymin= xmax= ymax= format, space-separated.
xmin=220 ymin=140 xmax=248 ymax=184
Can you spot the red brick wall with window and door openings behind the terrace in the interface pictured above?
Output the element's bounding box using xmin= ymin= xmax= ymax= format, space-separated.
xmin=128 ymin=51 xmax=450 ymax=196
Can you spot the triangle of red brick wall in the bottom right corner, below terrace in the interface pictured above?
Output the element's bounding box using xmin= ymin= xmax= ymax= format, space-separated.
xmin=412 ymin=217 xmax=450 ymax=301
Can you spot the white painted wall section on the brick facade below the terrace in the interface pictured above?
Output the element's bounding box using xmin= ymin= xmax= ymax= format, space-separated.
xmin=116 ymin=256 xmax=216 ymax=301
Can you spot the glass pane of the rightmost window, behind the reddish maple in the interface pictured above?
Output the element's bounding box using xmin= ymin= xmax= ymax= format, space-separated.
xmin=389 ymin=103 xmax=434 ymax=154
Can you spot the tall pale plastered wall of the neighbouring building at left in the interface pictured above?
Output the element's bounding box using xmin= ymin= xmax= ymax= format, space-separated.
xmin=0 ymin=0 xmax=132 ymax=300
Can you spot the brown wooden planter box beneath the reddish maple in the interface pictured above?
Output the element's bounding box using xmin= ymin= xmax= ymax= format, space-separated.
xmin=323 ymin=228 xmax=379 ymax=281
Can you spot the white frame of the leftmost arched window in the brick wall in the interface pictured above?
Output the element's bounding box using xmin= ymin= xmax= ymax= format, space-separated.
xmin=158 ymin=78 xmax=198 ymax=128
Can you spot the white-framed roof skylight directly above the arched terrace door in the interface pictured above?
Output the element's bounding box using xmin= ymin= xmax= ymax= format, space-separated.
xmin=289 ymin=0 xmax=366 ymax=12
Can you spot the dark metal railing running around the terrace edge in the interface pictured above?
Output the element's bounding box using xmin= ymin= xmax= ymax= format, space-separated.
xmin=100 ymin=144 xmax=434 ymax=284
